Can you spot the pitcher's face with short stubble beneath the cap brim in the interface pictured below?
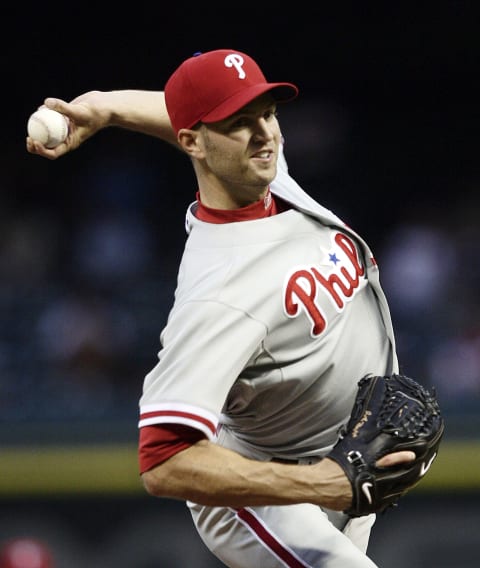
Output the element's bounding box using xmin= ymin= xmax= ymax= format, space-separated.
xmin=201 ymin=94 xmax=281 ymax=204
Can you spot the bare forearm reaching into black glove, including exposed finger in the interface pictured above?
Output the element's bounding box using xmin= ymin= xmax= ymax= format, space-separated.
xmin=142 ymin=439 xmax=412 ymax=511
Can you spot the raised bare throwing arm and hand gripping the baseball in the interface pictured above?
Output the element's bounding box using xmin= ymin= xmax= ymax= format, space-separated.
xmin=26 ymin=89 xmax=177 ymax=160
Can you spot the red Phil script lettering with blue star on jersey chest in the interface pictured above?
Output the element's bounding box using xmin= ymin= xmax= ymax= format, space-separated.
xmin=284 ymin=233 xmax=365 ymax=337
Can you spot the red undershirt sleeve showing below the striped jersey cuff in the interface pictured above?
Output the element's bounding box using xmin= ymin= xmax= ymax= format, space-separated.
xmin=138 ymin=424 xmax=206 ymax=473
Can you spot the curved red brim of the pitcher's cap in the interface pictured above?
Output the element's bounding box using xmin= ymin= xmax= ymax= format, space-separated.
xmin=201 ymin=83 xmax=298 ymax=123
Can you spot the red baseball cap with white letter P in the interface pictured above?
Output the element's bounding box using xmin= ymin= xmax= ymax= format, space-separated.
xmin=165 ymin=49 xmax=298 ymax=132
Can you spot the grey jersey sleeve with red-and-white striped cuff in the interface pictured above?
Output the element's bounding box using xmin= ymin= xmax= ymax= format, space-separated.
xmin=139 ymin=300 xmax=266 ymax=439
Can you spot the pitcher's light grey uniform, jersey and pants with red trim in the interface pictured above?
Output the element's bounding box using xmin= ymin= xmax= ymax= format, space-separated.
xmin=139 ymin=148 xmax=398 ymax=568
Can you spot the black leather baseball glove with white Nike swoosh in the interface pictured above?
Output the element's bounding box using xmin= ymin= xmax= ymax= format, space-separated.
xmin=326 ymin=374 xmax=444 ymax=517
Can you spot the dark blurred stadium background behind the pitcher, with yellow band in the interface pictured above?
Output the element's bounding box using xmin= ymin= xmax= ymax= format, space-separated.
xmin=0 ymin=1 xmax=480 ymax=568
